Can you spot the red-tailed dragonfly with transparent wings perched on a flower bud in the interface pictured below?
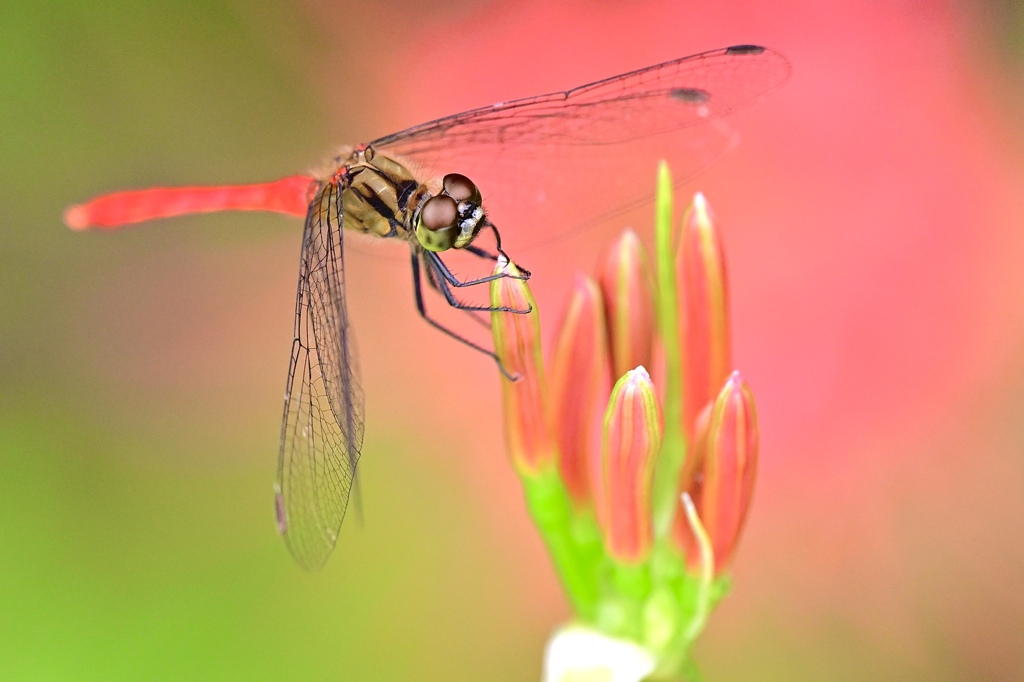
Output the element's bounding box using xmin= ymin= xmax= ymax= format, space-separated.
xmin=63 ymin=45 xmax=790 ymax=570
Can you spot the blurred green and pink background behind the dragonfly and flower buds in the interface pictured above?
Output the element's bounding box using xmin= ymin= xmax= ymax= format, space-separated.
xmin=6 ymin=0 xmax=1024 ymax=680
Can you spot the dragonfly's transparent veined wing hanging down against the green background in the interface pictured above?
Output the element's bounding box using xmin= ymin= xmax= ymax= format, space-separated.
xmin=275 ymin=176 xmax=365 ymax=570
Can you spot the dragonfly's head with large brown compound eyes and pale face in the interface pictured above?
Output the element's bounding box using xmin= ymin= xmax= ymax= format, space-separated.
xmin=416 ymin=173 xmax=486 ymax=252
